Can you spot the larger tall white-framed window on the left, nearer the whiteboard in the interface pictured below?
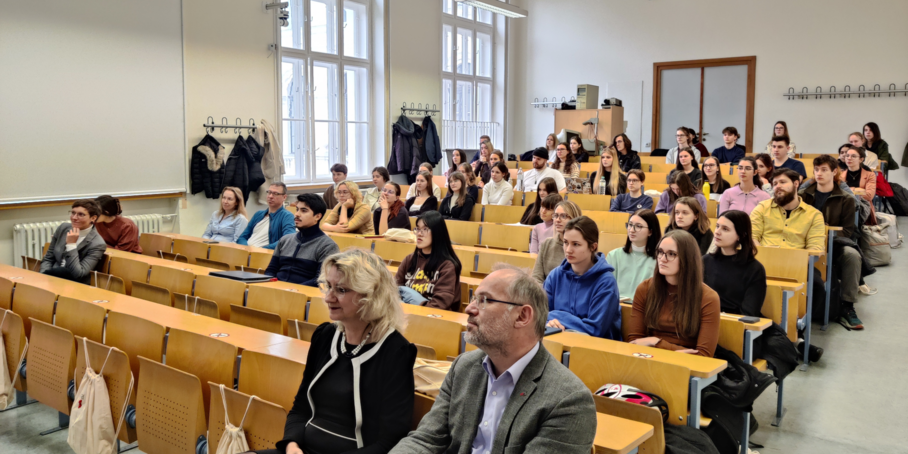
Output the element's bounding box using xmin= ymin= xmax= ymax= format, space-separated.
xmin=281 ymin=0 xmax=372 ymax=183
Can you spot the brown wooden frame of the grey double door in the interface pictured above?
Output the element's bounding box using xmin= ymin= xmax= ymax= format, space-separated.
xmin=650 ymin=55 xmax=757 ymax=153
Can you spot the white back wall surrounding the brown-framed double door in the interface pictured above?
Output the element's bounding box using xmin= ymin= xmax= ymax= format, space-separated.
xmin=506 ymin=0 xmax=908 ymax=181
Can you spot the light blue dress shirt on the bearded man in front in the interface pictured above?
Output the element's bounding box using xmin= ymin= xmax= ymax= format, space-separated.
xmin=472 ymin=342 xmax=539 ymax=454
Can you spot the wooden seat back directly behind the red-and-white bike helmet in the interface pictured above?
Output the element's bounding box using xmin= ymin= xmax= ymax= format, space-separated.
xmin=569 ymin=347 xmax=690 ymax=425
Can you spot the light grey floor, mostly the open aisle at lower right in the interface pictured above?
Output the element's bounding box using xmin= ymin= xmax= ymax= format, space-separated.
xmin=0 ymin=225 xmax=908 ymax=454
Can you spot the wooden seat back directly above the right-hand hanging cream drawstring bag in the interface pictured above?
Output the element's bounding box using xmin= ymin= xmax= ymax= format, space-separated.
xmin=165 ymin=328 xmax=237 ymax=418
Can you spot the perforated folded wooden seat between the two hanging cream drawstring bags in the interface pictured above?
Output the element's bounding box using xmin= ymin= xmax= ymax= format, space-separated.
xmin=136 ymin=357 xmax=208 ymax=453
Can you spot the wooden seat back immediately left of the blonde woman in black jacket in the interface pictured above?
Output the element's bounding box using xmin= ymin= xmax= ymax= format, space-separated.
xmin=238 ymin=350 xmax=306 ymax=414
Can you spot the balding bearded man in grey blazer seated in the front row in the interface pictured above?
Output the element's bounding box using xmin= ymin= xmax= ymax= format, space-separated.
xmin=388 ymin=267 xmax=596 ymax=454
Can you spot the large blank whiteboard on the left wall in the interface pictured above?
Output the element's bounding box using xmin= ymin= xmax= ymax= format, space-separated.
xmin=0 ymin=0 xmax=184 ymax=203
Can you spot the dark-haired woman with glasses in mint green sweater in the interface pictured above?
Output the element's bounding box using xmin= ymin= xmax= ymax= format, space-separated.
xmin=605 ymin=210 xmax=662 ymax=299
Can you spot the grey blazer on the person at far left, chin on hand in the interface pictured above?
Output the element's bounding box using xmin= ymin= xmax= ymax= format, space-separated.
xmin=41 ymin=222 xmax=107 ymax=284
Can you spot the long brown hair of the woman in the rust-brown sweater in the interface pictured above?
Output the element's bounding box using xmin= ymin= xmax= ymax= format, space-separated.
xmin=643 ymin=230 xmax=703 ymax=339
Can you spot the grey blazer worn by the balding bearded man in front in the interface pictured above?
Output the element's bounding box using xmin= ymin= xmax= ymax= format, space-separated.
xmin=391 ymin=345 xmax=596 ymax=454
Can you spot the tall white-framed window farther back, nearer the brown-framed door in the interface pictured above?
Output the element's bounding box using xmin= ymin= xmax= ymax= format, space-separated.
xmin=441 ymin=0 xmax=500 ymax=149
